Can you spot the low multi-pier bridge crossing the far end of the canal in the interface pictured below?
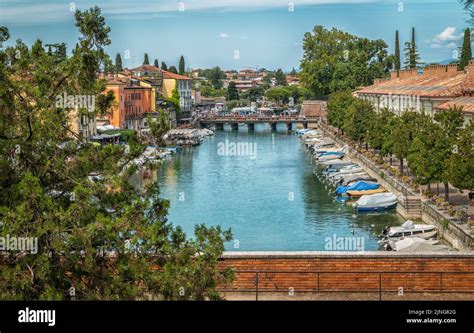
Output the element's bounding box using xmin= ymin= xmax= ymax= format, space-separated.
xmin=198 ymin=116 xmax=320 ymax=131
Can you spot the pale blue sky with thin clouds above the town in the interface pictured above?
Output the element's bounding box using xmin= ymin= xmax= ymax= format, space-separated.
xmin=0 ymin=0 xmax=468 ymax=71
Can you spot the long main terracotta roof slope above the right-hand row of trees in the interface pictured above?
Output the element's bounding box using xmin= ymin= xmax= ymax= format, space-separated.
xmin=356 ymin=72 xmax=466 ymax=97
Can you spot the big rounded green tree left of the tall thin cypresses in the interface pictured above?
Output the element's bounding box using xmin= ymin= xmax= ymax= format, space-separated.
xmin=299 ymin=26 xmax=394 ymax=96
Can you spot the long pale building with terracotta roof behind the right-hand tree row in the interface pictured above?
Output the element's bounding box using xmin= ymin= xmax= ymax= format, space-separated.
xmin=355 ymin=64 xmax=474 ymax=122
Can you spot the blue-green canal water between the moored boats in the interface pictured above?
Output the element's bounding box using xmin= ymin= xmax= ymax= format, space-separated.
xmin=153 ymin=124 xmax=403 ymax=251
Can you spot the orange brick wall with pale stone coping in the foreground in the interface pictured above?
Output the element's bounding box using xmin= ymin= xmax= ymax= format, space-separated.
xmin=219 ymin=252 xmax=474 ymax=292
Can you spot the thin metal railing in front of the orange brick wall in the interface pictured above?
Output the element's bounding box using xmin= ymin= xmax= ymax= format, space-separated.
xmin=221 ymin=270 xmax=474 ymax=301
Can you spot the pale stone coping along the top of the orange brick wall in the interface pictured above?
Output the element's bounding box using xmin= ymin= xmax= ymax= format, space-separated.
xmin=221 ymin=251 xmax=474 ymax=259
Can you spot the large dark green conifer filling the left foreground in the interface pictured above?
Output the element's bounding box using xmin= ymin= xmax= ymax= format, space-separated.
xmin=0 ymin=7 xmax=232 ymax=300
